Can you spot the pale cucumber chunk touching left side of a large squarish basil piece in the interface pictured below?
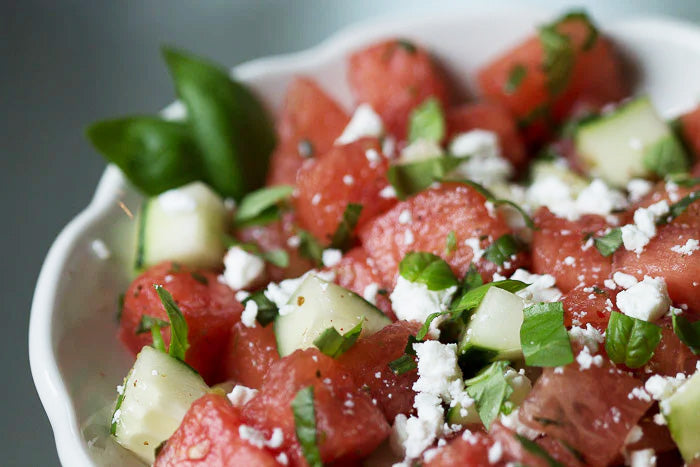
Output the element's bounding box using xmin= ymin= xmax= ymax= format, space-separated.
xmin=460 ymin=287 xmax=525 ymax=359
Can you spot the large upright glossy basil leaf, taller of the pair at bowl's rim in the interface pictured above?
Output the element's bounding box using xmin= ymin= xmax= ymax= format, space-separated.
xmin=163 ymin=48 xmax=275 ymax=200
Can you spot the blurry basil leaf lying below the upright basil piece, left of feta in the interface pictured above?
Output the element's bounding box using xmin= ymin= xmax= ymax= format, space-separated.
xmin=386 ymin=156 xmax=463 ymax=199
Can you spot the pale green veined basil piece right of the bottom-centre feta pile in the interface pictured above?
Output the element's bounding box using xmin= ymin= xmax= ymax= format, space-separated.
xmin=464 ymin=361 xmax=513 ymax=430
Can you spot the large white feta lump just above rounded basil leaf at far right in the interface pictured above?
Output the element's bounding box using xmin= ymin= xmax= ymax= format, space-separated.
xmin=617 ymin=276 xmax=671 ymax=322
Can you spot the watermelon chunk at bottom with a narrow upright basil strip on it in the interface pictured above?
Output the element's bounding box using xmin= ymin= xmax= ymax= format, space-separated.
xmin=243 ymin=349 xmax=390 ymax=463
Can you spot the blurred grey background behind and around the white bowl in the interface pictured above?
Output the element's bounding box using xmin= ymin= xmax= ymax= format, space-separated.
xmin=0 ymin=0 xmax=700 ymax=466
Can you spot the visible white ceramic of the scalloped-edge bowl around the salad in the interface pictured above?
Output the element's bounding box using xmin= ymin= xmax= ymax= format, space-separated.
xmin=29 ymin=7 xmax=700 ymax=466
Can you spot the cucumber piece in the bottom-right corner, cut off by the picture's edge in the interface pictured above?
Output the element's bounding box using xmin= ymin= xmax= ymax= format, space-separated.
xmin=661 ymin=371 xmax=700 ymax=464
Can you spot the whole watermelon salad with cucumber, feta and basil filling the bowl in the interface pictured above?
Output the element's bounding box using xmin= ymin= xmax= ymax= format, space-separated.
xmin=88 ymin=12 xmax=700 ymax=467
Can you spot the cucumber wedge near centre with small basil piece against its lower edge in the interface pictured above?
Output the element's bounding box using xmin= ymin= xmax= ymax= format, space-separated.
xmin=275 ymin=274 xmax=391 ymax=357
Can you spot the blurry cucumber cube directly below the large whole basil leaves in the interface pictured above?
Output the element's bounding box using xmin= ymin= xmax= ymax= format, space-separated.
xmin=136 ymin=182 xmax=226 ymax=270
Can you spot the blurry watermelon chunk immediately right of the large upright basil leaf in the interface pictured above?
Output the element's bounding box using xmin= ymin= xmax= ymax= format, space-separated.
xmin=267 ymin=77 xmax=350 ymax=185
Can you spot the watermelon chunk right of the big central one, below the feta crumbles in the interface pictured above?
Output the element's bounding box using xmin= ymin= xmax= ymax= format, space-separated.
xmin=531 ymin=207 xmax=612 ymax=292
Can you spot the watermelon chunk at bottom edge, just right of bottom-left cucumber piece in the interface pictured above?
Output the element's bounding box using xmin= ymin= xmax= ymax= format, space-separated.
xmin=153 ymin=394 xmax=281 ymax=467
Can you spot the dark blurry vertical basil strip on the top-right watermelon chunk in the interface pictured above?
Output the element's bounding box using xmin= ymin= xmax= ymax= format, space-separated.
xmin=539 ymin=25 xmax=575 ymax=96
